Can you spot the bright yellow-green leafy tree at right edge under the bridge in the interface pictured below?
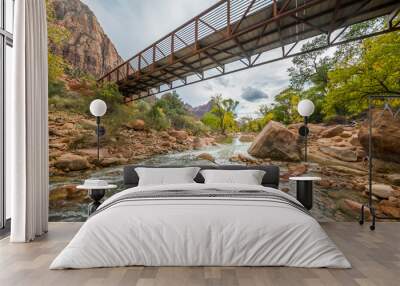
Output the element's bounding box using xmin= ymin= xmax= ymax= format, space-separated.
xmin=324 ymin=32 xmax=400 ymax=117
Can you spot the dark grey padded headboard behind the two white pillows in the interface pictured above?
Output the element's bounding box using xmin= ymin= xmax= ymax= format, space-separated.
xmin=124 ymin=165 xmax=279 ymax=189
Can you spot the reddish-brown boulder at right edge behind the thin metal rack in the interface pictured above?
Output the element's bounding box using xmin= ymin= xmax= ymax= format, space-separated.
xmin=358 ymin=110 xmax=400 ymax=163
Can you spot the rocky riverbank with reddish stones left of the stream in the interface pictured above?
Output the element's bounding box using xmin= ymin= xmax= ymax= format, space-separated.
xmin=49 ymin=112 xmax=217 ymax=176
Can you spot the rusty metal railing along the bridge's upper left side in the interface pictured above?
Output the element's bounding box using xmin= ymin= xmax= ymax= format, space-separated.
xmin=99 ymin=0 xmax=276 ymax=82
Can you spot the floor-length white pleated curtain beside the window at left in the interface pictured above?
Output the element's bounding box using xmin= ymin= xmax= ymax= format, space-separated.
xmin=6 ymin=0 xmax=49 ymax=242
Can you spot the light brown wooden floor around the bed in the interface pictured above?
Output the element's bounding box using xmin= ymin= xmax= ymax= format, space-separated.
xmin=0 ymin=222 xmax=400 ymax=286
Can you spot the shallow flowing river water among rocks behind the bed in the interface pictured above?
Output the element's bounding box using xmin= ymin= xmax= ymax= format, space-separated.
xmin=49 ymin=138 xmax=356 ymax=221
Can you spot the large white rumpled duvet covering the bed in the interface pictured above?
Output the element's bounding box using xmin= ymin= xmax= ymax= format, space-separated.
xmin=50 ymin=184 xmax=351 ymax=269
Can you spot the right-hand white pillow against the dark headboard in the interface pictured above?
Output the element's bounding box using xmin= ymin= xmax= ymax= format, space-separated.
xmin=200 ymin=170 xmax=265 ymax=185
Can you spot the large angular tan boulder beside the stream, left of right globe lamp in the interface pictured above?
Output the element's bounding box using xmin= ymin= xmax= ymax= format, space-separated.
xmin=248 ymin=121 xmax=301 ymax=161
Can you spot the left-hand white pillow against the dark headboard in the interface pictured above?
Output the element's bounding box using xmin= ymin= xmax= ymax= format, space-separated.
xmin=135 ymin=167 xmax=200 ymax=186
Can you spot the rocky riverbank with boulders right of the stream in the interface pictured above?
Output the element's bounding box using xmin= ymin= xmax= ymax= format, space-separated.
xmin=230 ymin=115 xmax=400 ymax=218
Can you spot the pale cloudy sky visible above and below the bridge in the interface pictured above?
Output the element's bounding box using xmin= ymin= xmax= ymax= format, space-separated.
xmin=83 ymin=0 xmax=291 ymax=116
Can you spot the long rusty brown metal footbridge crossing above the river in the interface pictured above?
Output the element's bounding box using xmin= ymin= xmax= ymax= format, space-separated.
xmin=98 ymin=0 xmax=400 ymax=102
